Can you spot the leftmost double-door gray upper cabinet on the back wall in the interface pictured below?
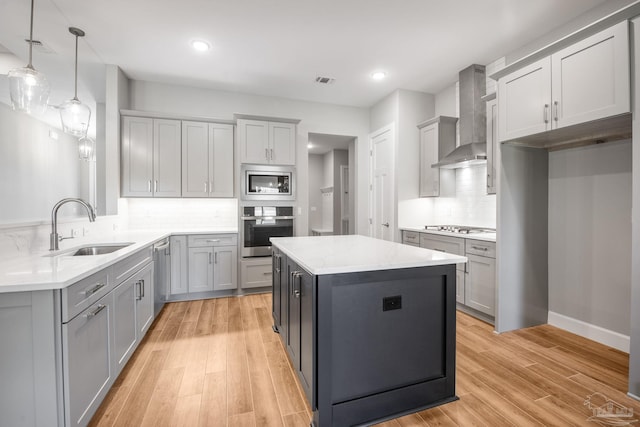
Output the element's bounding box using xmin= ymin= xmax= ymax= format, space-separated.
xmin=122 ymin=116 xmax=181 ymax=197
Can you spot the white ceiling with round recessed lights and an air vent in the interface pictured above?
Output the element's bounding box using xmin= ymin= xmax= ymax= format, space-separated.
xmin=0 ymin=0 xmax=629 ymax=107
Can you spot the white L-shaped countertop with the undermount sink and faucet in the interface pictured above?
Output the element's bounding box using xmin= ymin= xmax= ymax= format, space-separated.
xmin=0 ymin=228 xmax=238 ymax=293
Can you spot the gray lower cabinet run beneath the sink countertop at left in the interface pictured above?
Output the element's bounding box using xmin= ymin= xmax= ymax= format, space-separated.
xmin=0 ymin=247 xmax=154 ymax=427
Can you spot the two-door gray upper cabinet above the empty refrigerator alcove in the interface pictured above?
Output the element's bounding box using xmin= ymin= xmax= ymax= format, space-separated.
xmin=498 ymin=21 xmax=630 ymax=141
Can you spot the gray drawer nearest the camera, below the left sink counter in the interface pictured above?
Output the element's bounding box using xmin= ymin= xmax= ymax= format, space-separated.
xmin=62 ymin=269 xmax=111 ymax=323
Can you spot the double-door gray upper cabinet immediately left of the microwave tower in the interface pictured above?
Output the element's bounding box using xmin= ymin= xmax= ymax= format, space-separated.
xmin=182 ymin=121 xmax=234 ymax=197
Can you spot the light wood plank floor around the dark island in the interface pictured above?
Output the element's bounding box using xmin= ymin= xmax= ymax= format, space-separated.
xmin=91 ymin=294 xmax=640 ymax=427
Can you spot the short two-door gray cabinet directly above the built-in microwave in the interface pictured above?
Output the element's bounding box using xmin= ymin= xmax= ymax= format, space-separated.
xmin=238 ymin=119 xmax=296 ymax=165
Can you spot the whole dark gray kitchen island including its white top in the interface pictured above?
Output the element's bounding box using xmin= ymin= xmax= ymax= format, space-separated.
xmin=271 ymin=235 xmax=466 ymax=427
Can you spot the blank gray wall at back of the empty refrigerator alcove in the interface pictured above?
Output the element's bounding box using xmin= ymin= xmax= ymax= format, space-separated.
xmin=549 ymin=141 xmax=631 ymax=335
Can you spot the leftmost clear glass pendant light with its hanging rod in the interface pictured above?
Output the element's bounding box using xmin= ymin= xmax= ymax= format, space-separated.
xmin=8 ymin=0 xmax=49 ymax=114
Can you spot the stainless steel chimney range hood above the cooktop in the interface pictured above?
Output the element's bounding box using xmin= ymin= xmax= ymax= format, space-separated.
xmin=431 ymin=64 xmax=487 ymax=169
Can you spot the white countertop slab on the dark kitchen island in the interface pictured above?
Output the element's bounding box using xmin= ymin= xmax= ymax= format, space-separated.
xmin=271 ymin=235 xmax=467 ymax=274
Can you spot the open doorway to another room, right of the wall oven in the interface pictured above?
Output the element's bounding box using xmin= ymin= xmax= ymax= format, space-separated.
xmin=308 ymin=133 xmax=356 ymax=236
